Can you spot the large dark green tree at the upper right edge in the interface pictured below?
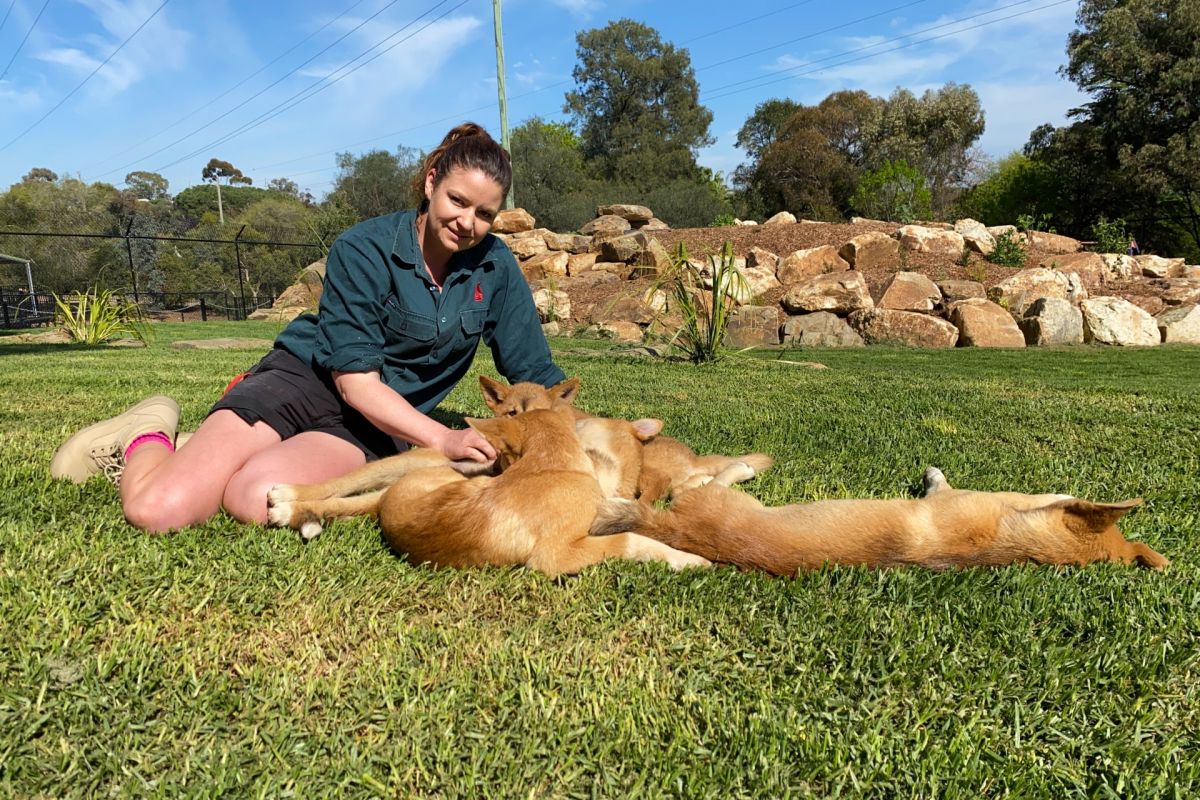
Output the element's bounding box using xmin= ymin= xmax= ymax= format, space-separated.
xmin=1063 ymin=0 xmax=1200 ymax=249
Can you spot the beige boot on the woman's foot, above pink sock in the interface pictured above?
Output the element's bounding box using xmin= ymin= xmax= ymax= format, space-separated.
xmin=50 ymin=395 xmax=179 ymax=486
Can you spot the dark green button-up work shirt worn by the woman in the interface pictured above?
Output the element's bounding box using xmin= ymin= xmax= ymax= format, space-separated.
xmin=275 ymin=210 xmax=565 ymax=414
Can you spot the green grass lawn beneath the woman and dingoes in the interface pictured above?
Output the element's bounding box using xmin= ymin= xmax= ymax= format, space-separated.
xmin=0 ymin=323 xmax=1200 ymax=798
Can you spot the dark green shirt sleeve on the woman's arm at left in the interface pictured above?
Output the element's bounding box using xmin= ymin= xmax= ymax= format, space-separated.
xmin=316 ymin=239 xmax=388 ymax=372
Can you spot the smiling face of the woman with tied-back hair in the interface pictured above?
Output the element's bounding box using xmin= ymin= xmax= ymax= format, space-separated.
xmin=425 ymin=167 xmax=504 ymax=253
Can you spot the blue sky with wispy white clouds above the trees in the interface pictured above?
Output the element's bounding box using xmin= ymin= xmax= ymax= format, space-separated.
xmin=0 ymin=0 xmax=1086 ymax=203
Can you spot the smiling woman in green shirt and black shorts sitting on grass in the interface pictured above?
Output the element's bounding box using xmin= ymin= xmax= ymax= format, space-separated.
xmin=50 ymin=122 xmax=565 ymax=531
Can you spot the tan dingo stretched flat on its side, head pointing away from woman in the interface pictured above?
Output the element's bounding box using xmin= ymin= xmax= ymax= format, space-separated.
xmin=592 ymin=468 xmax=1169 ymax=575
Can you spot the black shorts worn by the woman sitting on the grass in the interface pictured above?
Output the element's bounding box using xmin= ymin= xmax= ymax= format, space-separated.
xmin=209 ymin=348 xmax=401 ymax=462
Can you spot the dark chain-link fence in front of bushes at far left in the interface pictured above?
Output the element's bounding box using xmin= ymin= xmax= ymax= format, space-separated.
xmin=0 ymin=210 xmax=324 ymax=327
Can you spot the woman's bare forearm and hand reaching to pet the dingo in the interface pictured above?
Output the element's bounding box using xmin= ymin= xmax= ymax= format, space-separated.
xmin=334 ymin=372 xmax=496 ymax=462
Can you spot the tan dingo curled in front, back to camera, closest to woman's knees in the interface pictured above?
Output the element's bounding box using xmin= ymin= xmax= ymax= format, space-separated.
xmin=269 ymin=408 xmax=708 ymax=576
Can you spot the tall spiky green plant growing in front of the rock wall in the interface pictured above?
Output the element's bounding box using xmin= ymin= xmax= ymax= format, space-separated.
xmin=654 ymin=240 xmax=749 ymax=363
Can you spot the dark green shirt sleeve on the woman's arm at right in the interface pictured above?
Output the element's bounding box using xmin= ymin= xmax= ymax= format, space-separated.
xmin=484 ymin=252 xmax=566 ymax=386
